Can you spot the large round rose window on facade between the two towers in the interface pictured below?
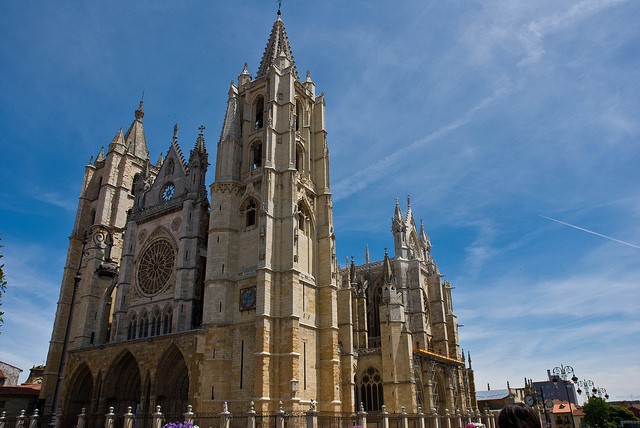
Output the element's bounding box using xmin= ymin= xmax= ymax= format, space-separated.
xmin=138 ymin=240 xmax=176 ymax=296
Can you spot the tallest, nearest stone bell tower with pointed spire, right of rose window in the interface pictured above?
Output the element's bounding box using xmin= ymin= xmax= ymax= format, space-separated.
xmin=202 ymin=12 xmax=341 ymax=411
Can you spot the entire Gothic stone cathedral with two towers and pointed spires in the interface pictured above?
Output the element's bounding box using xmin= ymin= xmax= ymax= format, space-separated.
xmin=40 ymin=12 xmax=477 ymax=424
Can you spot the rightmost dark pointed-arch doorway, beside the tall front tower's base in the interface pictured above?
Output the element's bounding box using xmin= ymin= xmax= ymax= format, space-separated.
xmin=156 ymin=345 xmax=189 ymax=417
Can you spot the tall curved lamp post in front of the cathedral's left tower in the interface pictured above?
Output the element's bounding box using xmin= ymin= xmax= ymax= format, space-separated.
xmin=49 ymin=224 xmax=118 ymax=427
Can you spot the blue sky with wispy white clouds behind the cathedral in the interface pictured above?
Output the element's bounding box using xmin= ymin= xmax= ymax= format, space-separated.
xmin=0 ymin=0 xmax=640 ymax=399
